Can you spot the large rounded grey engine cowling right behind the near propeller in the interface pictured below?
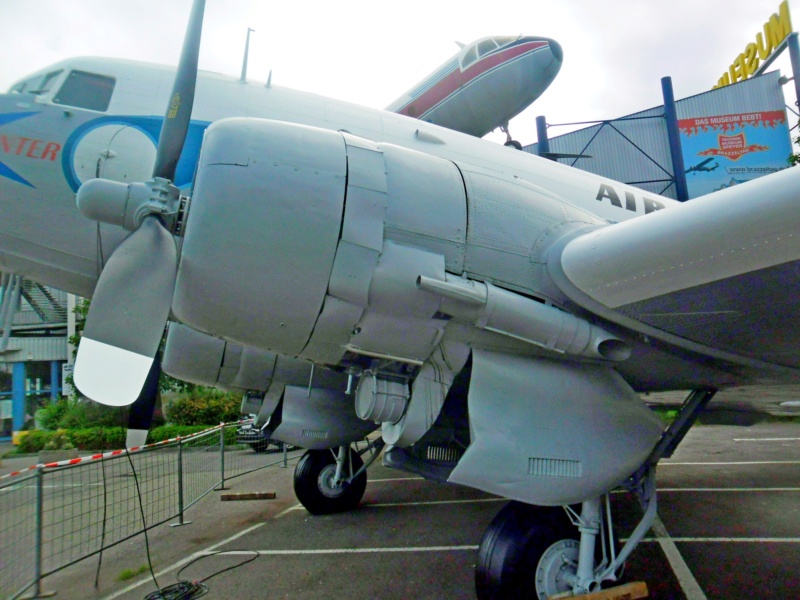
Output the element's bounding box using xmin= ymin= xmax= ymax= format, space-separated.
xmin=172 ymin=119 xmax=466 ymax=364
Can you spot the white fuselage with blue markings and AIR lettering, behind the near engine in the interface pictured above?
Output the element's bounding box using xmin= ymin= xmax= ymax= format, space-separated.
xmin=0 ymin=58 xmax=675 ymax=296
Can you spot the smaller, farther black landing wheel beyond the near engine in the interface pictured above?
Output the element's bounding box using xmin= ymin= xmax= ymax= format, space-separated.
xmin=294 ymin=449 xmax=367 ymax=515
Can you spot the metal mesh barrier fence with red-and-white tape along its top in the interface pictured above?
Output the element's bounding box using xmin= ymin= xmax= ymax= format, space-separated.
xmin=0 ymin=424 xmax=296 ymax=599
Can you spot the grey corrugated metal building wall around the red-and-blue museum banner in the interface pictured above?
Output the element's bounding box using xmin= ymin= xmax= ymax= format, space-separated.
xmin=523 ymin=71 xmax=784 ymax=198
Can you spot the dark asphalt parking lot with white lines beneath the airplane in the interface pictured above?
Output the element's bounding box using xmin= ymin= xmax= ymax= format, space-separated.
xmin=4 ymin=392 xmax=800 ymax=600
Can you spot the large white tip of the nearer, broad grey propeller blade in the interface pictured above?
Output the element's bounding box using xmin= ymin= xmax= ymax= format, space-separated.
xmin=73 ymin=336 xmax=153 ymax=406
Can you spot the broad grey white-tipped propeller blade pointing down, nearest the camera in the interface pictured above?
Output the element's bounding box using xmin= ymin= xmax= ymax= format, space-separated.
xmin=74 ymin=216 xmax=178 ymax=406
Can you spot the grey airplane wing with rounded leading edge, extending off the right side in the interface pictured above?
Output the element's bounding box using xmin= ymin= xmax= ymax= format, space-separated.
xmin=549 ymin=168 xmax=800 ymax=368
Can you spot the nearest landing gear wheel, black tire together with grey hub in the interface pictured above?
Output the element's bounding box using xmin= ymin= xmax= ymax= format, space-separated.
xmin=475 ymin=502 xmax=580 ymax=600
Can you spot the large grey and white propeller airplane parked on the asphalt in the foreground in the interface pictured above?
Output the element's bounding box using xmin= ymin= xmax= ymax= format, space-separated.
xmin=0 ymin=1 xmax=800 ymax=598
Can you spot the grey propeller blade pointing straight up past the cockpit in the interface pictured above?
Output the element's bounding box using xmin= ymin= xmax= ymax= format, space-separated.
xmin=153 ymin=0 xmax=206 ymax=181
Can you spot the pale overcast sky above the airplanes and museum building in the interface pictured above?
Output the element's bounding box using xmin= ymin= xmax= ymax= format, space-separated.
xmin=0 ymin=0 xmax=800 ymax=143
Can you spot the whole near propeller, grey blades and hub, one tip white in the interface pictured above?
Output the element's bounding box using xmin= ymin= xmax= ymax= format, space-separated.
xmin=74 ymin=0 xmax=205 ymax=413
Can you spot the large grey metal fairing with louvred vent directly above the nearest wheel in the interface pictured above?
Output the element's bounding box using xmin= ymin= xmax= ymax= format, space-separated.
xmin=450 ymin=351 xmax=663 ymax=505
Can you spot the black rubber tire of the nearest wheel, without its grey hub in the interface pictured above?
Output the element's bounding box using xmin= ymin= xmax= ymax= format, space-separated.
xmin=475 ymin=502 xmax=579 ymax=600
